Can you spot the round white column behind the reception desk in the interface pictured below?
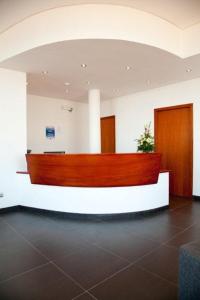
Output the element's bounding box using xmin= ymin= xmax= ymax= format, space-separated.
xmin=88 ymin=89 xmax=101 ymax=153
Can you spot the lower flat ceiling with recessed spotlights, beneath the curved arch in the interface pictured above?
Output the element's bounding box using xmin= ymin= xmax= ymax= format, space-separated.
xmin=0 ymin=40 xmax=200 ymax=101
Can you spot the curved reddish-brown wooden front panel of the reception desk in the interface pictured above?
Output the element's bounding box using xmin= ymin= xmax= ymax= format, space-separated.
xmin=26 ymin=153 xmax=161 ymax=187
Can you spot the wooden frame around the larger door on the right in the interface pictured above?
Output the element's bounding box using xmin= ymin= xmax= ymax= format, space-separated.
xmin=154 ymin=103 xmax=194 ymax=196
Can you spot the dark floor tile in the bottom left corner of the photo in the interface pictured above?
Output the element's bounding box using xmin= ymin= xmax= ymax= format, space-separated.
xmin=0 ymin=264 xmax=83 ymax=300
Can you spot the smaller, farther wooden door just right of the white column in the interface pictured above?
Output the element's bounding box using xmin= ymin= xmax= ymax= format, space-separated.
xmin=101 ymin=116 xmax=115 ymax=153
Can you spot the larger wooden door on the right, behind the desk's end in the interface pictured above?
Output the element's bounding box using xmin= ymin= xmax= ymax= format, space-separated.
xmin=154 ymin=104 xmax=193 ymax=197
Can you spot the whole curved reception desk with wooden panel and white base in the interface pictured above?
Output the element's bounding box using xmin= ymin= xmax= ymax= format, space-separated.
xmin=18 ymin=153 xmax=169 ymax=215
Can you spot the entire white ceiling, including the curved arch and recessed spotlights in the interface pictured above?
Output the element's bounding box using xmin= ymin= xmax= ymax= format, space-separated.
xmin=0 ymin=0 xmax=200 ymax=101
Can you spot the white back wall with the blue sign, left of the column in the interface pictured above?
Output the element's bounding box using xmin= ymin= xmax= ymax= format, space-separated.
xmin=27 ymin=95 xmax=89 ymax=153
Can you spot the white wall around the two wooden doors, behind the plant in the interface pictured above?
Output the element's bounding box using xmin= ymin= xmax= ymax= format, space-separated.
xmin=104 ymin=78 xmax=200 ymax=195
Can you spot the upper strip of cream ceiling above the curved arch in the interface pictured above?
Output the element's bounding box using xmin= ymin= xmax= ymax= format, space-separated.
xmin=0 ymin=0 xmax=200 ymax=32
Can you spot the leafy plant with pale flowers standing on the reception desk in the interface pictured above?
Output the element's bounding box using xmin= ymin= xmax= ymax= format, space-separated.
xmin=136 ymin=122 xmax=154 ymax=152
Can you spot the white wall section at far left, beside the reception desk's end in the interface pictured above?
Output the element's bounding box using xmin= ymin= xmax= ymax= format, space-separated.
xmin=0 ymin=69 xmax=26 ymax=208
